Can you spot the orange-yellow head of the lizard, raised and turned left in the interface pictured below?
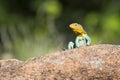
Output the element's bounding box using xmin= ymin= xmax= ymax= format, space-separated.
xmin=69 ymin=23 xmax=86 ymax=35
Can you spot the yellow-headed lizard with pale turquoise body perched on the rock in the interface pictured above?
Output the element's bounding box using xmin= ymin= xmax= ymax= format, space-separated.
xmin=68 ymin=23 xmax=91 ymax=48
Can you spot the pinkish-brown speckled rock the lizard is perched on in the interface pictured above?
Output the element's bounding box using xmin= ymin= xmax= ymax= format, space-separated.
xmin=0 ymin=44 xmax=120 ymax=80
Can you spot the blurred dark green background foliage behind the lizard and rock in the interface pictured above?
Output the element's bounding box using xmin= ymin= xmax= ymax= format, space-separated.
xmin=0 ymin=0 xmax=120 ymax=60
